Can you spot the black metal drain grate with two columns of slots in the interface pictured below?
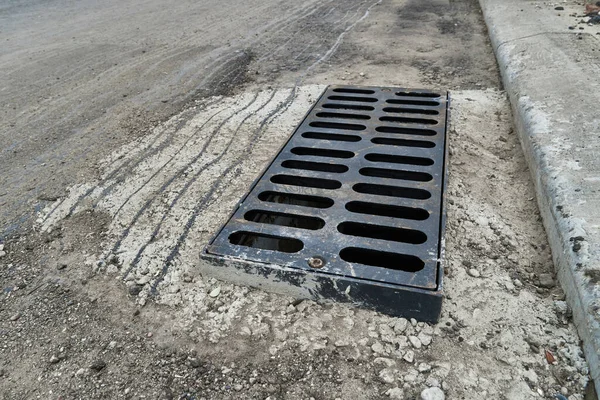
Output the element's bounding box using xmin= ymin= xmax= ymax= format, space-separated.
xmin=201 ymin=86 xmax=448 ymax=322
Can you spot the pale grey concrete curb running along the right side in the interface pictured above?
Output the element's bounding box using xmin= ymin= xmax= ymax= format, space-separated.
xmin=479 ymin=0 xmax=600 ymax=393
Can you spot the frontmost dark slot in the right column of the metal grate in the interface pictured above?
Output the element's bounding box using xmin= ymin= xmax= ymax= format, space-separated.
xmin=340 ymin=247 xmax=425 ymax=272
